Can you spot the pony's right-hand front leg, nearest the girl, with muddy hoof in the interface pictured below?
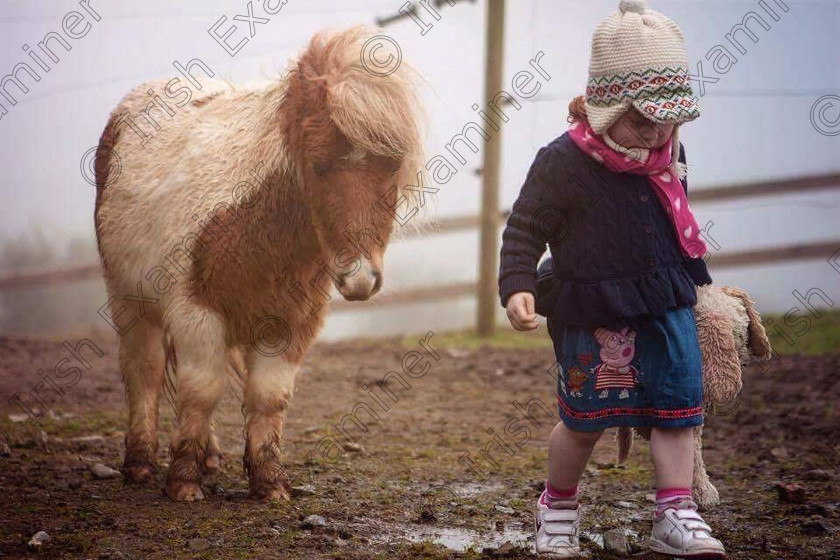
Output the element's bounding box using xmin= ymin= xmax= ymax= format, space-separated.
xmin=243 ymin=350 xmax=299 ymax=500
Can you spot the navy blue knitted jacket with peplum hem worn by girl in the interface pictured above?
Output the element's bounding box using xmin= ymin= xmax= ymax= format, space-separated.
xmin=499 ymin=133 xmax=712 ymax=328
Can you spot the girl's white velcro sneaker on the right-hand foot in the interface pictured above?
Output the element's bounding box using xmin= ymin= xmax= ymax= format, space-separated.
xmin=648 ymin=500 xmax=726 ymax=558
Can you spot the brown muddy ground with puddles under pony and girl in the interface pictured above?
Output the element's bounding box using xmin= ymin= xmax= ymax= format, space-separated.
xmin=0 ymin=333 xmax=840 ymax=560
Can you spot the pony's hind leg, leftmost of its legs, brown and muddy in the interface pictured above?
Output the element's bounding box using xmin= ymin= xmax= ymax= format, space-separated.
xmin=119 ymin=321 xmax=165 ymax=482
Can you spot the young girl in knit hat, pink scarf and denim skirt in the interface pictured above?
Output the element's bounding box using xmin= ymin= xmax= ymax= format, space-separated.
xmin=499 ymin=0 xmax=725 ymax=558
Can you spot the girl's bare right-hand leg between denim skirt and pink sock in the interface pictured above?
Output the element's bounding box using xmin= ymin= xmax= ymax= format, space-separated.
xmin=650 ymin=427 xmax=694 ymax=490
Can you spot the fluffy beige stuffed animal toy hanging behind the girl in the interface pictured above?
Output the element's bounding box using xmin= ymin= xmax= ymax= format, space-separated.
xmin=617 ymin=286 xmax=771 ymax=509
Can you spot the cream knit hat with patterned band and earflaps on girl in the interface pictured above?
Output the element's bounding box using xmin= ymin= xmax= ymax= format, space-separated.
xmin=586 ymin=0 xmax=700 ymax=134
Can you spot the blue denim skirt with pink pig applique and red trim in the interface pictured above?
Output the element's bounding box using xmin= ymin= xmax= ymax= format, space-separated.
xmin=548 ymin=307 xmax=703 ymax=431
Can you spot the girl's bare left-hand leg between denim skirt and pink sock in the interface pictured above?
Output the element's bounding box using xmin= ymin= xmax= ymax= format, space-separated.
xmin=548 ymin=422 xmax=604 ymax=489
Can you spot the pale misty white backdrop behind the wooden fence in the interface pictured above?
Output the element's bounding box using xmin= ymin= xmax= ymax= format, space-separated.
xmin=0 ymin=0 xmax=840 ymax=337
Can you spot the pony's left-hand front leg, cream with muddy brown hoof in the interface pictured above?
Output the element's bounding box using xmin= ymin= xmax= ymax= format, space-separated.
xmin=166 ymin=306 xmax=227 ymax=502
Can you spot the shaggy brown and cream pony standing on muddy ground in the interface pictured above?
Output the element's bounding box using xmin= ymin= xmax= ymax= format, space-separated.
xmin=95 ymin=28 xmax=423 ymax=501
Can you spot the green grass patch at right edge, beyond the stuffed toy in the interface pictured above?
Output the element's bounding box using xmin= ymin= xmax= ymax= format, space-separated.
xmin=762 ymin=309 xmax=840 ymax=356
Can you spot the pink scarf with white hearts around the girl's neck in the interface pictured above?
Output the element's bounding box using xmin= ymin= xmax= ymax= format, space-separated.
xmin=569 ymin=120 xmax=706 ymax=258
